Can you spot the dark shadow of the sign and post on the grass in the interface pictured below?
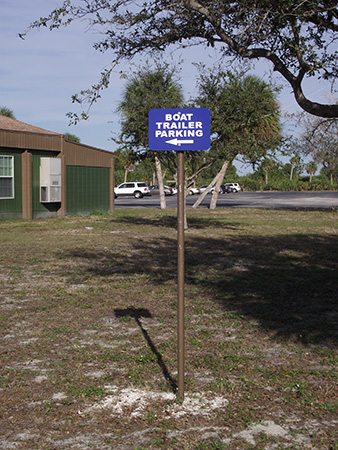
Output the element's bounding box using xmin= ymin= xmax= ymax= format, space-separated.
xmin=114 ymin=306 xmax=177 ymax=393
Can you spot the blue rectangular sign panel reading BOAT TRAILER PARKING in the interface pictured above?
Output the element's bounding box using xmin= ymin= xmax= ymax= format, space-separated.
xmin=148 ymin=108 xmax=210 ymax=151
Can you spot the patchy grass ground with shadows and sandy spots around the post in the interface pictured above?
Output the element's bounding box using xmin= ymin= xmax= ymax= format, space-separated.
xmin=0 ymin=209 xmax=338 ymax=450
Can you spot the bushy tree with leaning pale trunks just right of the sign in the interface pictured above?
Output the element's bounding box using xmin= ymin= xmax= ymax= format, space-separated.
xmin=194 ymin=71 xmax=281 ymax=209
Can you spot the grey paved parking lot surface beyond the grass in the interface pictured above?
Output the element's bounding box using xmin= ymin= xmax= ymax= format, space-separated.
xmin=115 ymin=191 xmax=338 ymax=209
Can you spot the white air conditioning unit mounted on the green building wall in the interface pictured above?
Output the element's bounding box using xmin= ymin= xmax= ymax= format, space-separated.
xmin=40 ymin=158 xmax=61 ymax=203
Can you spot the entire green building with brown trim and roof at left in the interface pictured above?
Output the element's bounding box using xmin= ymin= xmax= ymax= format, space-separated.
xmin=0 ymin=115 xmax=115 ymax=220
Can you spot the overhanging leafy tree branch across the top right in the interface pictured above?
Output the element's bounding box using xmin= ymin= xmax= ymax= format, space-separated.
xmin=20 ymin=0 xmax=338 ymax=117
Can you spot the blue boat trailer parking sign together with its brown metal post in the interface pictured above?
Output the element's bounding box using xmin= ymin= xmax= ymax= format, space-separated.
xmin=149 ymin=108 xmax=210 ymax=402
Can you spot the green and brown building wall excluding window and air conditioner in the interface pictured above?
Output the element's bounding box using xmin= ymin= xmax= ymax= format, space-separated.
xmin=0 ymin=128 xmax=114 ymax=220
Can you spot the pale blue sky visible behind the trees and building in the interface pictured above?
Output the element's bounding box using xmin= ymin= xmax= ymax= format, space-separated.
xmin=0 ymin=0 xmax=336 ymax=174
